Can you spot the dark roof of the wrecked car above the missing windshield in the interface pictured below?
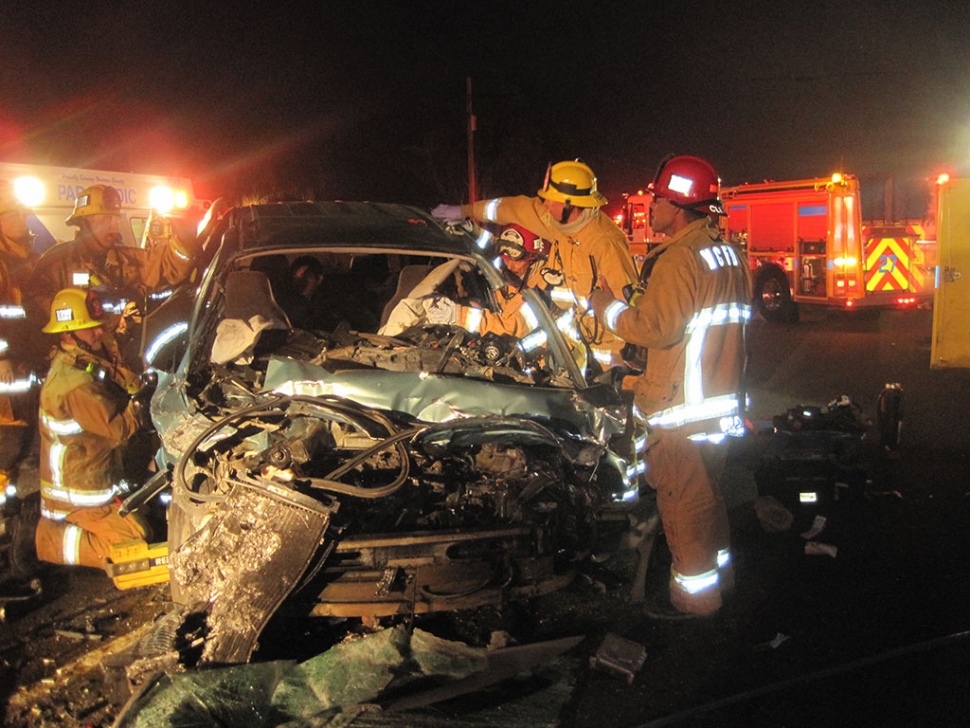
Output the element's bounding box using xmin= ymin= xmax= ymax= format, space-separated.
xmin=227 ymin=201 xmax=472 ymax=255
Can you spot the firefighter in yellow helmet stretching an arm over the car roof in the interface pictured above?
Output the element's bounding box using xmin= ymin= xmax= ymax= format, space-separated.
xmin=431 ymin=160 xmax=637 ymax=370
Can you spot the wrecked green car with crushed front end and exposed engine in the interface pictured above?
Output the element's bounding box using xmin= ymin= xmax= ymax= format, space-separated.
xmin=144 ymin=202 xmax=637 ymax=664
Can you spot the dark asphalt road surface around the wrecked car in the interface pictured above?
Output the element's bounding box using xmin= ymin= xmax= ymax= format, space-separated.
xmin=0 ymin=304 xmax=970 ymax=728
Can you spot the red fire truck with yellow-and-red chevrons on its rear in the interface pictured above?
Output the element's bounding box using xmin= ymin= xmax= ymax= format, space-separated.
xmin=721 ymin=174 xmax=936 ymax=321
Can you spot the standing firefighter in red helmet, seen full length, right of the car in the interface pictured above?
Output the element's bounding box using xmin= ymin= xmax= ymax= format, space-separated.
xmin=592 ymin=156 xmax=751 ymax=617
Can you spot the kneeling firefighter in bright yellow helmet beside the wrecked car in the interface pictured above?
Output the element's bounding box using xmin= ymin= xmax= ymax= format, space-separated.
xmin=35 ymin=288 xmax=148 ymax=568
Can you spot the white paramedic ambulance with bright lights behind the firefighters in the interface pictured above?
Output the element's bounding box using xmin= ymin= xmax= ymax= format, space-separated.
xmin=0 ymin=162 xmax=201 ymax=252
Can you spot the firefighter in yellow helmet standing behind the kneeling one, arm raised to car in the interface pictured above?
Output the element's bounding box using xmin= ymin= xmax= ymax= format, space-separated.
xmin=25 ymin=184 xmax=194 ymax=369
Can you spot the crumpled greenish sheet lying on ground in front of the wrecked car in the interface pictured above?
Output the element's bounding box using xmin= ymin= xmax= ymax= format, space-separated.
xmin=115 ymin=625 xmax=582 ymax=728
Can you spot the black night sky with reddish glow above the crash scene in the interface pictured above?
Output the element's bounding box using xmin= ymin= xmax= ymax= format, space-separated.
xmin=0 ymin=0 xmax=970 ymax=213
